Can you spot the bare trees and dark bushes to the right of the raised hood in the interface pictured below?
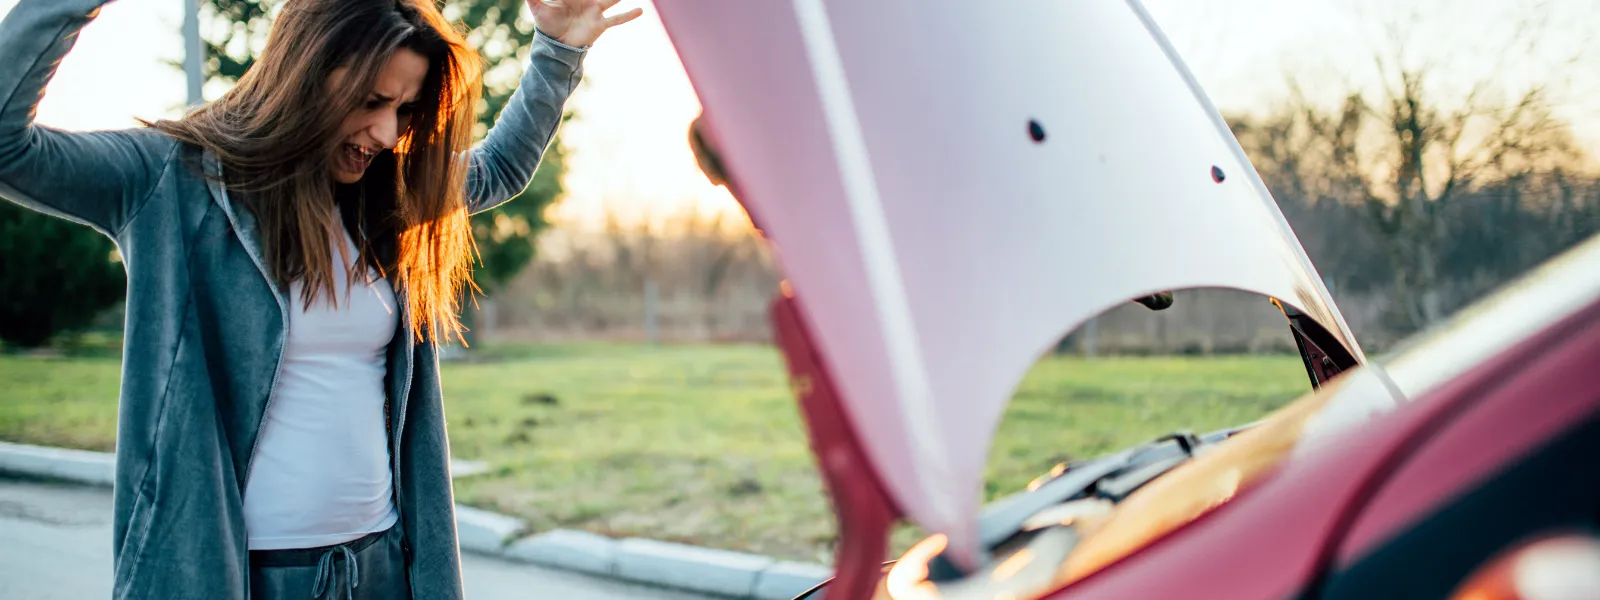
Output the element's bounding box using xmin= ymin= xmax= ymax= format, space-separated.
xmin=1229 ymin=78 xmax=1600 ymax=333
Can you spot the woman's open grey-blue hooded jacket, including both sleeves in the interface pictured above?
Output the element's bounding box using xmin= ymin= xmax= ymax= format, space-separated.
xmin=0 ymin=0 xmax=584 ymax=600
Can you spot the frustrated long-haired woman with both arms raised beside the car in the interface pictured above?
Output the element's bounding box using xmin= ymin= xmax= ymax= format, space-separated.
xmin=0 ymin=0 xmax=640 ymax=598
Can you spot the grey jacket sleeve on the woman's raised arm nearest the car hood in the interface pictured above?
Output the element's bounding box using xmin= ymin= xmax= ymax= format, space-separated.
xmin=467 ymin=32 xmax=589 ymax=213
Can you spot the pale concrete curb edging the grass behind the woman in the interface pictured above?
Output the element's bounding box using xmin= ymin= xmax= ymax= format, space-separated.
xmin=0 ymin=442 xmax=832 ymax=600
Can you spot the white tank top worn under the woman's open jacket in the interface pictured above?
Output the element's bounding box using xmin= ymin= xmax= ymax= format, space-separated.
xmin=245 ymin=227 xmax=398 ymax=550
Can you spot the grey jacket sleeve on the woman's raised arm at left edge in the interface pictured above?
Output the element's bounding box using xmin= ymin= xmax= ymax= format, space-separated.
xmin=0 ymin=0 xmax=171 ymax=237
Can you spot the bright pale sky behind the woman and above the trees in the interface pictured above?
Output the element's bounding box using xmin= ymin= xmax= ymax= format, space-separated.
xmin=0 ymin=0 xmax=1600 ymax=232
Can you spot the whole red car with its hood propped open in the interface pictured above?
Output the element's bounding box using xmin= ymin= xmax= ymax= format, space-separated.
xmin=656 ymin=0 xmax=1600 ymax=600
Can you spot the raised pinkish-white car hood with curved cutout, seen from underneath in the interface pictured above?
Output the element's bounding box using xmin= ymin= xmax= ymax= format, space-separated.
xmin=656 ymin=0 xmax=1365 ymax=582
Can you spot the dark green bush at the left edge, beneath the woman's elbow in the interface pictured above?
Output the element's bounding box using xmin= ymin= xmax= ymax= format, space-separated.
xmin=0 ymin=202 xmax=126 ymax=347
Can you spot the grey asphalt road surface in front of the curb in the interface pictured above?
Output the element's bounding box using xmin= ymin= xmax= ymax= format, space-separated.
xmin=0 ymin=478 xmax=706 ymax=600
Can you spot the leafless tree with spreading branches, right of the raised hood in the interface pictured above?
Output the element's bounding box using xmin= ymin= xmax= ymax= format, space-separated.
xmin=1246 ymin=3 xmax=1584 ymax=326
